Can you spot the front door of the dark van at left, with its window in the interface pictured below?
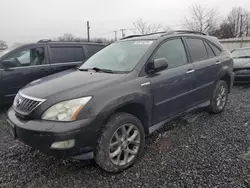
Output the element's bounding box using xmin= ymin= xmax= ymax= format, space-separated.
xmin=0 ymin=45 xmax=50 ymax=103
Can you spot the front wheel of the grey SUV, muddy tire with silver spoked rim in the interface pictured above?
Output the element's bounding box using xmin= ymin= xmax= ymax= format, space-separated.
xmin=95 ymin=113 xmax=145 ymax=173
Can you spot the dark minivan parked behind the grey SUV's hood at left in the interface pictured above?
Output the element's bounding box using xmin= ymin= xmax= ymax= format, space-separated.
xmin=0 ymin=40 xmax=105 ymax=104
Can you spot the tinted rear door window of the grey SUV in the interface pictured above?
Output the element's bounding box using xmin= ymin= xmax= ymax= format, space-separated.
xmin=187 ymin=38 xmax=207 ymax=62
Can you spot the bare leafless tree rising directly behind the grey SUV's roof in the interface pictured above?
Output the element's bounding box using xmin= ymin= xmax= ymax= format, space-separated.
xmin=185 ymin=4 xmax=218 ymax=34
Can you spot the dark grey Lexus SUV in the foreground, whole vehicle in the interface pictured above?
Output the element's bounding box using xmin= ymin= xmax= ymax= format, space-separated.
xmin=7 ymin=31 xmax=234 ymax=172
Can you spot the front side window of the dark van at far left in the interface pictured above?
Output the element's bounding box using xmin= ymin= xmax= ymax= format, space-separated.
xmin=2 ymin=47 xmax=45 ymax=68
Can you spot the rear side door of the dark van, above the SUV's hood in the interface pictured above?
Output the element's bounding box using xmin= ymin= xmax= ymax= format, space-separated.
xmin=49 ymin=44 xmax=86 ymax=73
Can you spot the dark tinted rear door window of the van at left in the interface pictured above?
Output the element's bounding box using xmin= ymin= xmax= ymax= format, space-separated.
xmin=50 ymin=46 xmax=86 ymax=64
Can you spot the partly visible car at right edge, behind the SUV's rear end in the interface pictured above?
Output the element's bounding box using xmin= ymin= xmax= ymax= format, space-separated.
xmin=232 ymin=47 xmax=250 ymax=84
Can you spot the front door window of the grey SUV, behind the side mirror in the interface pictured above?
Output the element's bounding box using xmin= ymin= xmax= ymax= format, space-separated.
xmin=153 ymin=39 xmax=187 ymax=68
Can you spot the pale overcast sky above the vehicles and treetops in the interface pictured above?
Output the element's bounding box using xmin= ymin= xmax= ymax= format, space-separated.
xmin=0 ymin=0 xmax=250 ymax=44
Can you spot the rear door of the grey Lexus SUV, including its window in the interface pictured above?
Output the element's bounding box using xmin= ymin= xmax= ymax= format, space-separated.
xmin=186 ymin=37 xmax=221 ymax=104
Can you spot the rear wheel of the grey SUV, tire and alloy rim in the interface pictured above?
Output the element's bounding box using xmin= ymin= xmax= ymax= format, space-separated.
xmin=208 ymin=80 xmax=228 ymax=114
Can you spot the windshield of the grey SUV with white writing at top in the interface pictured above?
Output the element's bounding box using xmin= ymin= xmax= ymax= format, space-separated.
xmin=79 ymin=40 xmax=153 ymax=72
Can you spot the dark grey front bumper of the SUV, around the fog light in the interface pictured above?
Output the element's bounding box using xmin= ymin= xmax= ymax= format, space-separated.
xmin=7 ymin=107 xmax=99 ymax=159
